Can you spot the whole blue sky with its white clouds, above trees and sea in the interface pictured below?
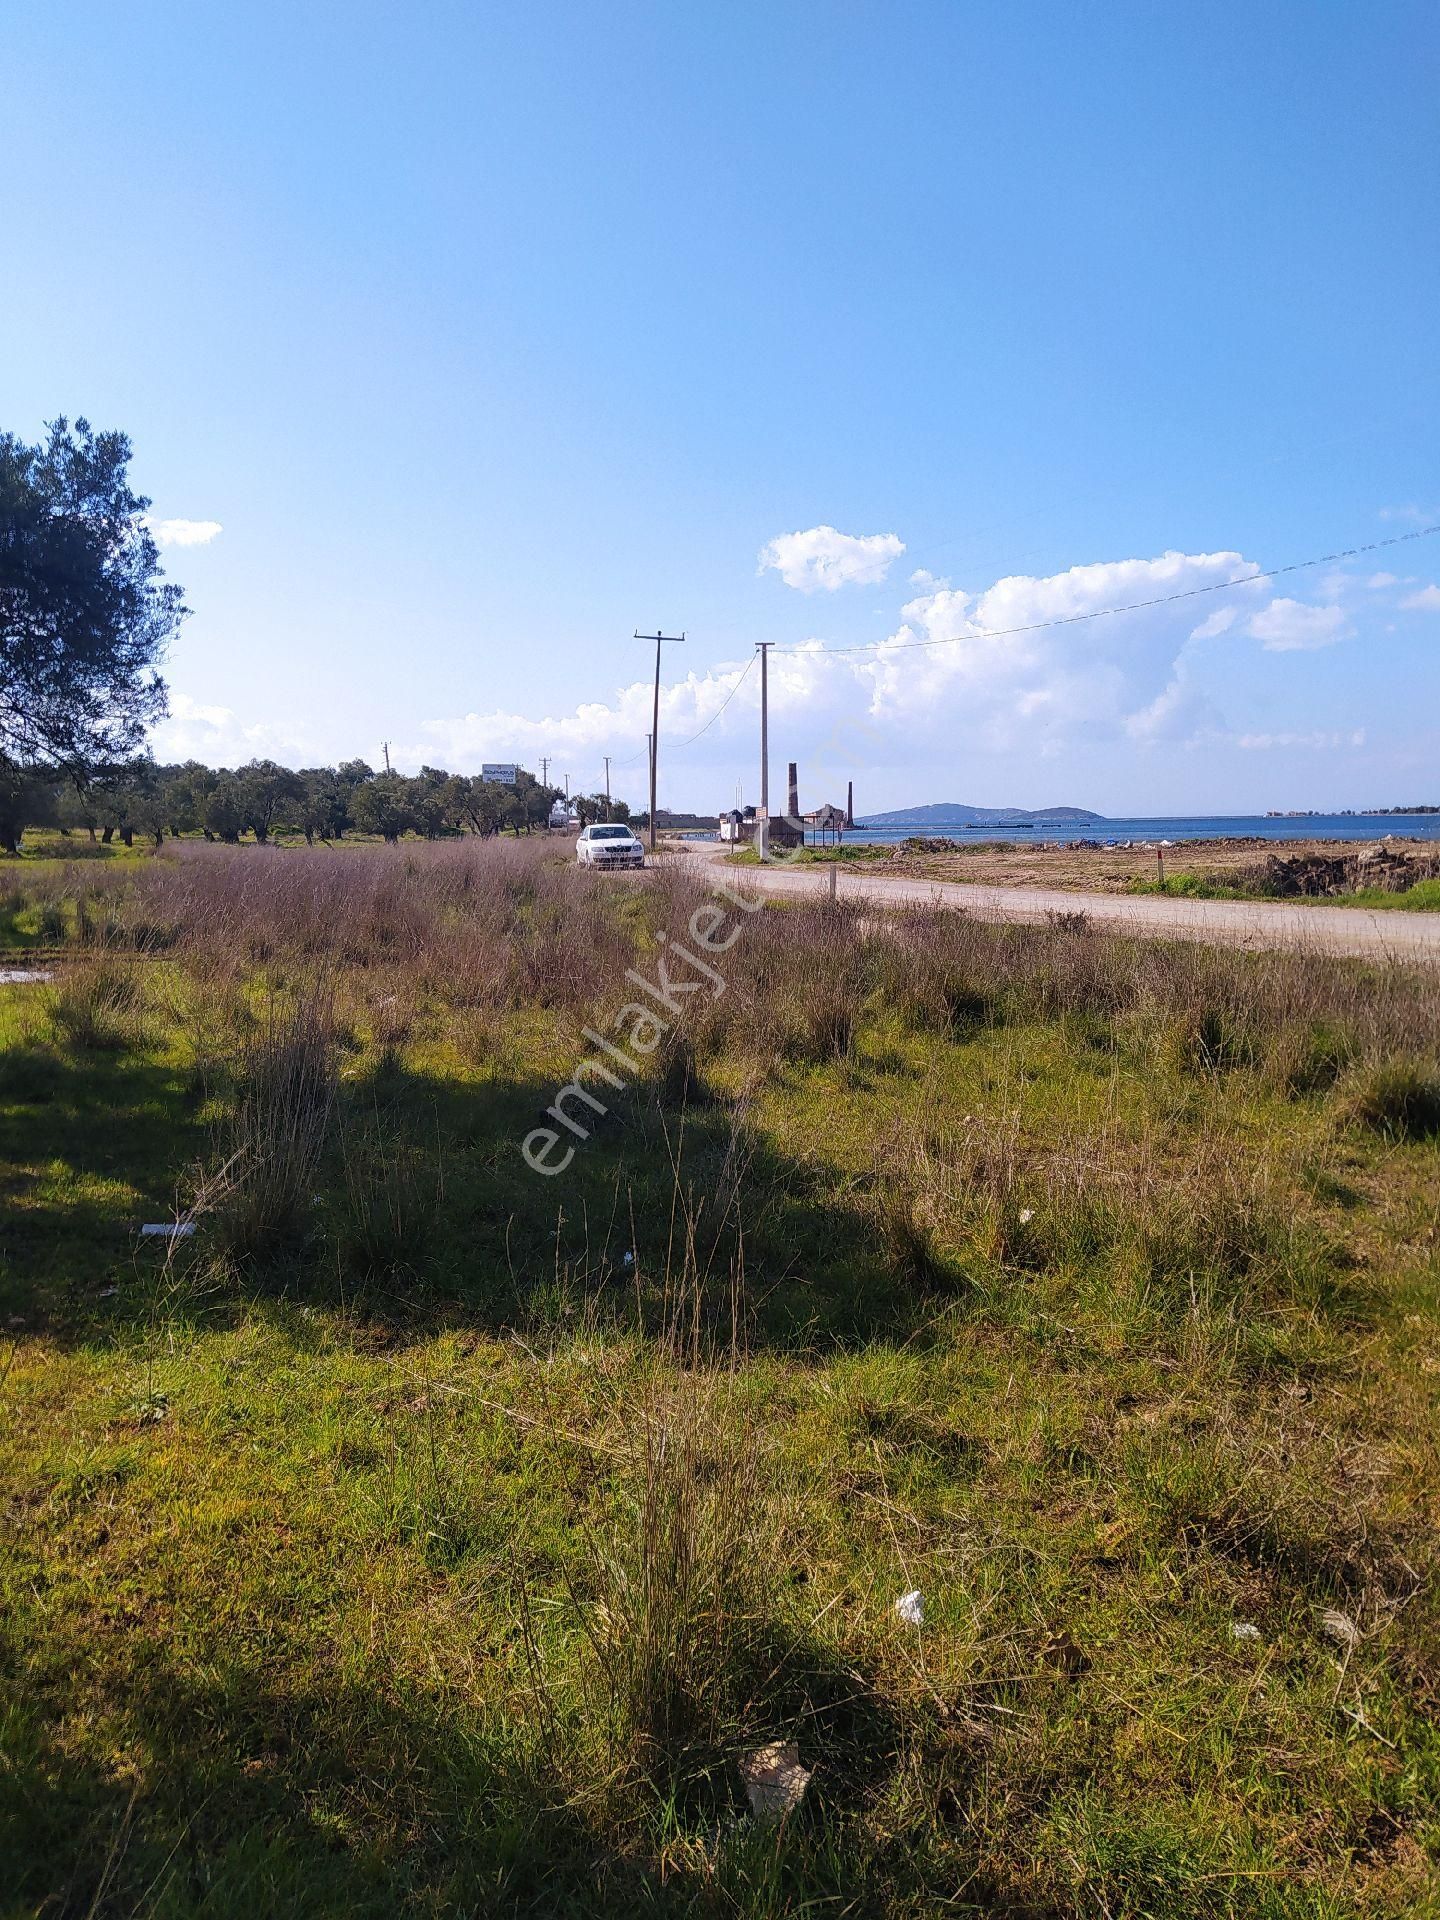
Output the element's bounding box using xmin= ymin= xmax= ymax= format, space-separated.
xmin=0 ymin=0 xmax=1440 ymax=812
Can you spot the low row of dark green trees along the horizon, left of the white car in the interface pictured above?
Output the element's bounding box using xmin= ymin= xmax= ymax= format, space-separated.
xmin=0 ymin=756 xmax=630 ymax=852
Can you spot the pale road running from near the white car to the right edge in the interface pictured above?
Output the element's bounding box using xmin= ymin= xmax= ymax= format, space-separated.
xmin=682 ymin=843 xmax=1440 ymax=966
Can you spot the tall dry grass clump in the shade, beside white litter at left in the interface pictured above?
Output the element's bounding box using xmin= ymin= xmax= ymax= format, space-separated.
xmin=208 ymin=995 xmax=336 ymax=1265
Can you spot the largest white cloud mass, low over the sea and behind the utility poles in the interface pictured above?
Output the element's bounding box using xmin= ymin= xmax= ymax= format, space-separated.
xmin=401 ymin=553 xmax=1263 ymax=804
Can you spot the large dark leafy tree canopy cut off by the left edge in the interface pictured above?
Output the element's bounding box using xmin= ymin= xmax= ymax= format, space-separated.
xmin=0 ymin=419 xmax=188 ymax=770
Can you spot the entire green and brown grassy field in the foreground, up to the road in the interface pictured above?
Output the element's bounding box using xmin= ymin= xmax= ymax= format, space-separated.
xmin=0 ymin=841 xmax=1440 ymax=1920
